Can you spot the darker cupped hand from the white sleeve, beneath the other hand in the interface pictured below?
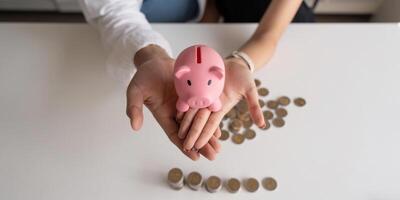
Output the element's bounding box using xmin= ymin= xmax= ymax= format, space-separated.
xmin=126 ymin=47 xmax=220 ymax=160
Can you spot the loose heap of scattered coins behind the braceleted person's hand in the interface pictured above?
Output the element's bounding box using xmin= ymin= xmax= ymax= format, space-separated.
xmin=219 ymin=79 xmax=306 ymax=144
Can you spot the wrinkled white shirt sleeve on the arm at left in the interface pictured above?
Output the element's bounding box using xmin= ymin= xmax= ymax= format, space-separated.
xmin=80 ymin=0 xmax=172 ymax=82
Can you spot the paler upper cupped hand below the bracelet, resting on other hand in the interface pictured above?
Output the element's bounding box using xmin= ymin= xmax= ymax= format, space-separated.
xmin=178 ymin=58 xmax=265 ymax=151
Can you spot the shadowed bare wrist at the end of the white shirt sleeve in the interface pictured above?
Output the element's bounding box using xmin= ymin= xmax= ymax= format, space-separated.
xmin=133 ymin=44 xmax=172 ymax=66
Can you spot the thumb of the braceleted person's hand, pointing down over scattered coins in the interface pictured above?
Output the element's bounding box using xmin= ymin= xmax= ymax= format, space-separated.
xmin=245 ymin=85 xmax=265 ymax=128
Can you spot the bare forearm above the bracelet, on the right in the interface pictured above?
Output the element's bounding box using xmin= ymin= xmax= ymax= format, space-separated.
xmin=239 ymin=0 xmax=302 ymax=69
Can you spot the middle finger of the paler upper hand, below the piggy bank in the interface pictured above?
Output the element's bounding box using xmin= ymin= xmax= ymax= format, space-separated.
xmin=183 ymin=108 xmax=214 ymax=149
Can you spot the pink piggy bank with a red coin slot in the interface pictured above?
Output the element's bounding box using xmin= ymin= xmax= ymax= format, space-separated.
xmin=174 ymin=45 xmax=225 ymax=112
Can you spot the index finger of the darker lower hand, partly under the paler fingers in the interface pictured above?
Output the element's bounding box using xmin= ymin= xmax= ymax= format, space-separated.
xmin=156 ymin=117 xmax=200 ymax=160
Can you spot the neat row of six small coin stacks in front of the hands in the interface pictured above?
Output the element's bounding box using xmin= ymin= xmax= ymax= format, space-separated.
xmin=167 ymin=168 xmax=278 ymax=193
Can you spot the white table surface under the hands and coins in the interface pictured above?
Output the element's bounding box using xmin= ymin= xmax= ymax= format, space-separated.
xmin=0 ymin=24 xmax=400 ymax=200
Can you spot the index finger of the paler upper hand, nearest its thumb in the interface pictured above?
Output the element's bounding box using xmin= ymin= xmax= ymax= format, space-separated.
xmin=194 ymin=111 xmax=224 ymax=149
